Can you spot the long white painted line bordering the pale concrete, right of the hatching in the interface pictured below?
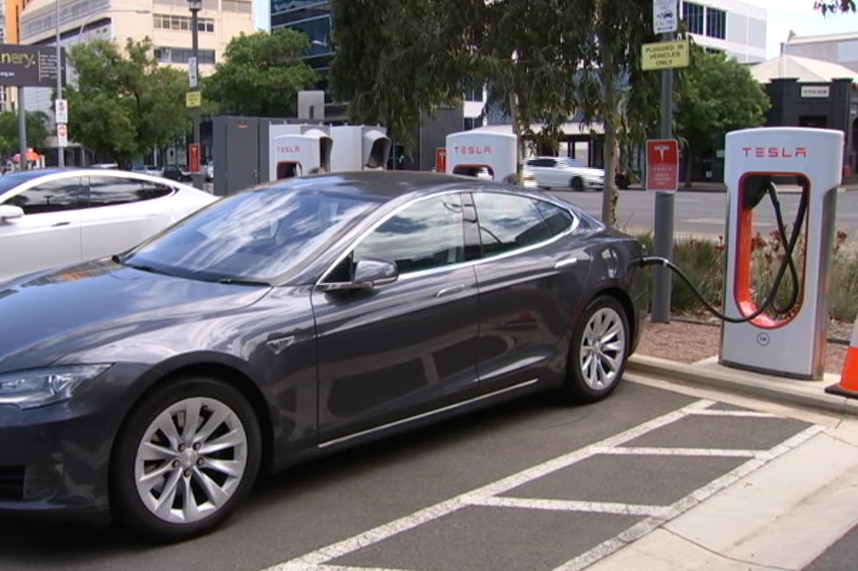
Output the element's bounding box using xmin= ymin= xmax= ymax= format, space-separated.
xmin=553 ymin=426 xmax=825 ymax=571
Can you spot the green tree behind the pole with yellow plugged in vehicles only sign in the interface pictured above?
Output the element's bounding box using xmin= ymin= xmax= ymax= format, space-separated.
xmin=673 ymin=46 xmax=771 ymax=188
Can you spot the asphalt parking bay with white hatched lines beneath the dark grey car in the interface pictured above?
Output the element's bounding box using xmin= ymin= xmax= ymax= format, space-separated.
xmin=0 ymin=382 xmax=811 ymax=571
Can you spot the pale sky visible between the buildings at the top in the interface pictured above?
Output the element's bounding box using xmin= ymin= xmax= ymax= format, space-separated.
xmin=253 ymin=0 xmax=858 ymax=58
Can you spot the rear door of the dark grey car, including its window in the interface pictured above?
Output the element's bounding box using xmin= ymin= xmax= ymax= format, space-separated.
xmin=473 ymin=191 xmax=590 ymax=390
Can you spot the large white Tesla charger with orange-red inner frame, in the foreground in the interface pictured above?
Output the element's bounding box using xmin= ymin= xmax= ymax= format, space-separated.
xmin=719 ymin=127 xmax=843 ymax=380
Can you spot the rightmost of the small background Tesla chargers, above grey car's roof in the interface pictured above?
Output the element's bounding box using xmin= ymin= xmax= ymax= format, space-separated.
xmin=447 ymin=131 xmax=516 ymax=181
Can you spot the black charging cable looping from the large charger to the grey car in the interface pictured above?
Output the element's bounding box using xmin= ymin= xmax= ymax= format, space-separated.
xmin=639 ymin=185 xmax=807 ymax=323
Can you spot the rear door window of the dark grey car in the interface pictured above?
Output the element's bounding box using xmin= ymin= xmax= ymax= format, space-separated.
xmin=474 ymin=192 xmax=552 ymax=257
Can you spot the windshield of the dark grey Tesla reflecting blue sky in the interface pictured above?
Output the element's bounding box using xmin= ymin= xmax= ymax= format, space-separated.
xmin=122 ymin=186 xmax=378 ymax=283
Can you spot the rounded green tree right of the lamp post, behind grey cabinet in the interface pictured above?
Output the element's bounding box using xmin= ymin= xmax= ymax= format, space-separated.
xmin=203 ymin=28 xmax=318 ymax=117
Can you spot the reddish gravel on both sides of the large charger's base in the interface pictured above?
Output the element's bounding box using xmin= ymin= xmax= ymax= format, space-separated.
xmin=637 ymin=319 xmax=852 ymax=374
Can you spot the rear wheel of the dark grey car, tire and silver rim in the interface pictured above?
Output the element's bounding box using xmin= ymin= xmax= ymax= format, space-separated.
xmin=564 ymin=296 xmax=631 ymax=403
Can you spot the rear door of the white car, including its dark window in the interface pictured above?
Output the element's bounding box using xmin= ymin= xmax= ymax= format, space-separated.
xmin=81 ymin=173 xmax=174 ymax=260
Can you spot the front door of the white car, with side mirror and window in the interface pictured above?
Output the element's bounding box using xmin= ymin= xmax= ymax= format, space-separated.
xmin=0 ymin=177 xmax=82 ymax=280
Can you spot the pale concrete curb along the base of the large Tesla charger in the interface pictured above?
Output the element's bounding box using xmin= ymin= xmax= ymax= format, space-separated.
xmin=626 ymin=355 xmax=858 ymax=417
